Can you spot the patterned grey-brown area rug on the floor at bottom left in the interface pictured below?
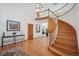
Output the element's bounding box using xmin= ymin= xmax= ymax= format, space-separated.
xmin=0 ymin=47 xmax=29 ymax=56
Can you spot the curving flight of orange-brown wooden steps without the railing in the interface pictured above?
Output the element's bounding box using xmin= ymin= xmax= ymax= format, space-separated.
xmin=49 ymin=20 xmax=78 ymax=56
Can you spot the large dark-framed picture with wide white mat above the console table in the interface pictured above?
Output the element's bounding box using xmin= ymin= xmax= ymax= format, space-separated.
xmin=7 ymin=20 xmax=20 ymax=31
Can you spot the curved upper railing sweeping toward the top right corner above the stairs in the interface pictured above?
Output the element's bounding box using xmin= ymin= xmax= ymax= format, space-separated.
xmin=52 ymin=3 xmax=76 ymax=17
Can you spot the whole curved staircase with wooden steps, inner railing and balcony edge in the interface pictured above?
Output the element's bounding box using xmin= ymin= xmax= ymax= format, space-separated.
xmin=35 ymin=3 xmax=78 ymax=56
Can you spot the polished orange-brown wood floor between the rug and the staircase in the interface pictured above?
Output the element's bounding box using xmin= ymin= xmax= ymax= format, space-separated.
xmin=0 ymin=37 xmax=55 ymax=56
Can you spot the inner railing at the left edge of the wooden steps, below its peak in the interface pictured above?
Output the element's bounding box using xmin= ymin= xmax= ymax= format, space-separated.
xmin=48 ymin=9 xmax=58 ymax=46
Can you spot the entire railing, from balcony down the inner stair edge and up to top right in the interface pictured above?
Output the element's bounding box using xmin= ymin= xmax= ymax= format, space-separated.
xmin=36 ymin=3 xmax=76 ymax=46
